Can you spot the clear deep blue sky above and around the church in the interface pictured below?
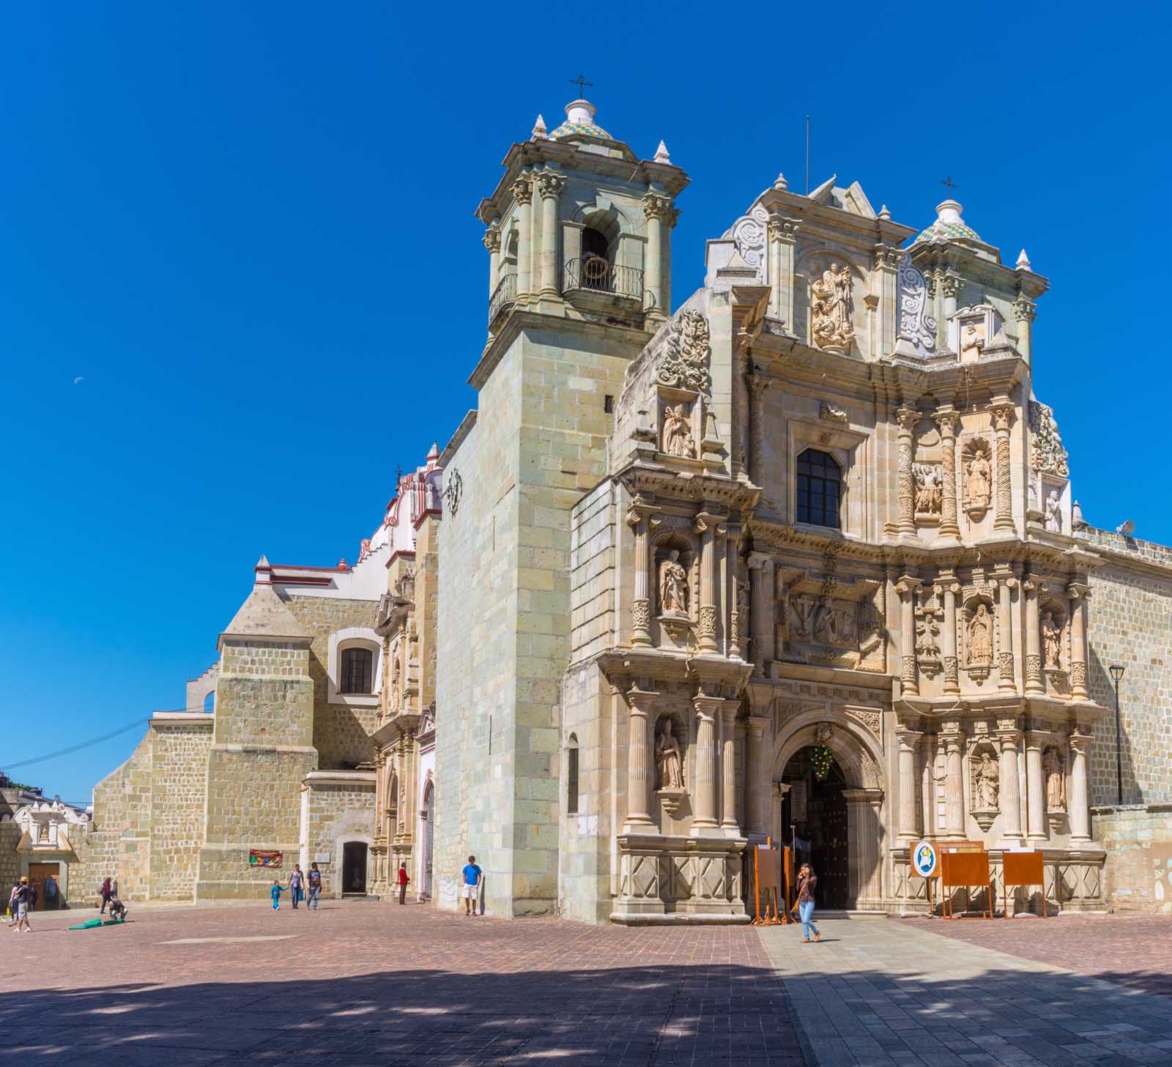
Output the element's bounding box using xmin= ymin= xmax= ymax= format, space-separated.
xmin=0 ymin=0 xmax=1172 ymax=800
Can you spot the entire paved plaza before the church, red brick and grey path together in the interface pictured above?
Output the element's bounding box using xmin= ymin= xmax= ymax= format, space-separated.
xmin=0 ymin=903 xmax=1172 ymax=1067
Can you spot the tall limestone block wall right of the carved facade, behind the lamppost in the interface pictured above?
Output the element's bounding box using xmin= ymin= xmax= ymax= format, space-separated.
xmin=1088 ymin=531 xmax=1172 ymax=804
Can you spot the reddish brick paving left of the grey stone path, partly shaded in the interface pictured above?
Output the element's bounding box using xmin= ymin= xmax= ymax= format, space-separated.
xmin=0 ymin=898 xmax=803 ymax=1067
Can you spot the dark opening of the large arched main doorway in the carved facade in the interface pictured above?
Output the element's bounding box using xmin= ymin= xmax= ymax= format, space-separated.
xmin=782 ymin=745 xmax=851 ymax=908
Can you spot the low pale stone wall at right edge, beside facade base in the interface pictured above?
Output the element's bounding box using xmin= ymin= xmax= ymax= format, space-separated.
xmin=1091 ymin=804 xmax=1172 ymax=913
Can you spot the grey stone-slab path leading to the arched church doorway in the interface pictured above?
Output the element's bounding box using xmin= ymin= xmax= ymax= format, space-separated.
xmin=761 ymin=918 xmax=1172 ymax=1067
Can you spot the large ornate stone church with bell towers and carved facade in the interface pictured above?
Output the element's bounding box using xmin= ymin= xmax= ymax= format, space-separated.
xmin=70 ymin=100 xmax=1172 ymax=923
